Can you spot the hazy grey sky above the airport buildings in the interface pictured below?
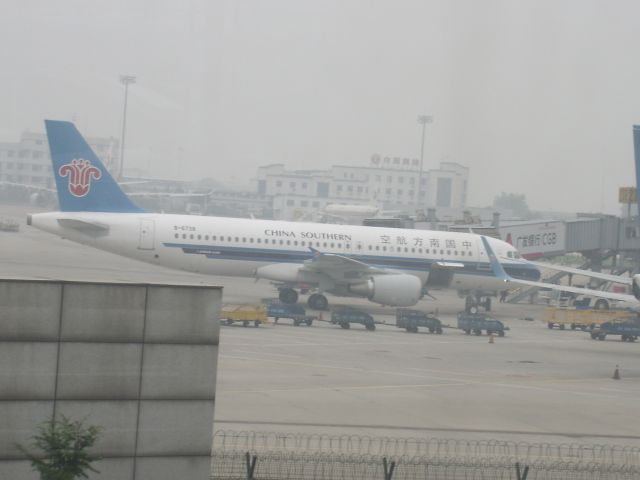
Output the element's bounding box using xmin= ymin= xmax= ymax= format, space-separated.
xmin=0 ymin=0 xmax=640 ymax=213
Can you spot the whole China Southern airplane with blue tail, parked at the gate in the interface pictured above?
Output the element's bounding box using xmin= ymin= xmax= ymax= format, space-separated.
xmin=27 ymin=120 xmax=540 ymax=310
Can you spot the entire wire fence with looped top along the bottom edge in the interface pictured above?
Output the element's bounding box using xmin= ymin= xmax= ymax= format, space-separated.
xmin=212 ymin=431 xmax=640 ymax=480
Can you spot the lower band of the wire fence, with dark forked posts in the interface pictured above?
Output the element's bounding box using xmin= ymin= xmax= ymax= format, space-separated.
xmin=211 ymin=451 xmax=640 ymax=480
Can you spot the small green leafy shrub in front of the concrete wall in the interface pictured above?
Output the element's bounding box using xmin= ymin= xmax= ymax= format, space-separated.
xmin=17 ymin=416 xmax=102 ymax=480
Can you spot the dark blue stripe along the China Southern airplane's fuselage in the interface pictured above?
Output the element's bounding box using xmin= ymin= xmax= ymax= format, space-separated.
xmin=163 ymin=243 xmax=540 ymax=281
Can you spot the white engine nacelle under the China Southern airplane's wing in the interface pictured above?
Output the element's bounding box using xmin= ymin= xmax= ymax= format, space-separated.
xmin=349 ymin=274 xmax=422 ymax=307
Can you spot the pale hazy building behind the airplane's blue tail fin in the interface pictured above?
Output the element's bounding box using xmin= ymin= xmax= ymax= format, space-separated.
xmin=0 ymin=132 xmax=119 ymax=188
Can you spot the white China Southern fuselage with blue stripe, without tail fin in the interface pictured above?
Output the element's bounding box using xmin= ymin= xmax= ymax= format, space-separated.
xmin=29 ymin=212 xmax=539 ymax=298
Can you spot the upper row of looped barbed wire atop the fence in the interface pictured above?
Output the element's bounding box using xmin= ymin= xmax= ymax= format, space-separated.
xmin=213 ymin=430 xmax=640 ymax=467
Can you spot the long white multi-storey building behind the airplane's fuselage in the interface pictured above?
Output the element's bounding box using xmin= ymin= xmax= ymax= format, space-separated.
xmin=256 ymin=155 xmax=469 ymax=220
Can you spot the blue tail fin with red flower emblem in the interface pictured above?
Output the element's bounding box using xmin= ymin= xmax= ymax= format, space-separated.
xmin=44 ymin=120 xmax=143 ymax=213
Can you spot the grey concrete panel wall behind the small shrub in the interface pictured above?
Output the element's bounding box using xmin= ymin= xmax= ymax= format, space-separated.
xmin=0 ymin=280 xmax=222 ymax=480
